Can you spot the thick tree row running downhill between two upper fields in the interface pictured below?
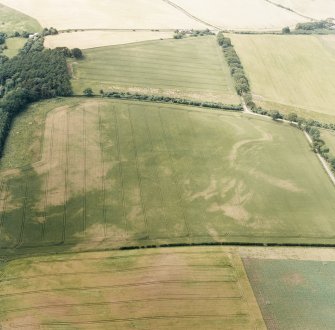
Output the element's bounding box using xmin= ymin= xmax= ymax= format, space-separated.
xmin=217 ymin=32 xmax=250 ymax=96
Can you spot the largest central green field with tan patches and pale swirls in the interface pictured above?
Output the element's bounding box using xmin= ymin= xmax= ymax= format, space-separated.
xmin=0 ymin=99 xmax=335 ymax=253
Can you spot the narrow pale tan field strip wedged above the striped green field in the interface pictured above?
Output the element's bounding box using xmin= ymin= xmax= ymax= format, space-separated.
xmin=44 ymin=31 xmax=173 ymax=49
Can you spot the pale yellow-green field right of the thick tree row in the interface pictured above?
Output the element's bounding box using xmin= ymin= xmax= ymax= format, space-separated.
xmin=231 ymin=35 xmax=335 ymax=122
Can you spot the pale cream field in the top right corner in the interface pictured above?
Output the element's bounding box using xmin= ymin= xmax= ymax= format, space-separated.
xmin=273 ymin=0 xmax=335 ymax=19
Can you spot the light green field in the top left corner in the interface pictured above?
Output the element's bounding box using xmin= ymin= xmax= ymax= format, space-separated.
xmin=0 ymin=4 xmax=42 ymax=34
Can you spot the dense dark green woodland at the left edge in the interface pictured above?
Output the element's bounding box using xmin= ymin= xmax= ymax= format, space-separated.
xmin=0 ymin=40 xmax=72 ymax=154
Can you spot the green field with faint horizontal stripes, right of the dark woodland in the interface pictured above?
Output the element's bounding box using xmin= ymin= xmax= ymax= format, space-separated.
xmin=72 ymin=36 xmax=240 ymax=104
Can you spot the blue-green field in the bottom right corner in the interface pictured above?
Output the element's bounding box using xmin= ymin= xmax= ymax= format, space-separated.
xmin=244 ymin=259 xmax=335 ymax=330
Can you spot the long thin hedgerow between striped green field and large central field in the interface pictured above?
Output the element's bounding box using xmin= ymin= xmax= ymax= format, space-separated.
xmin=96 ymin=88 xmax=243 ymax=111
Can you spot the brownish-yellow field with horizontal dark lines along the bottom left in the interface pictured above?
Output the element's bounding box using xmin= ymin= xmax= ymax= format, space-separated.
xmin=0 ymin=248 xmax=265 ymax=330
